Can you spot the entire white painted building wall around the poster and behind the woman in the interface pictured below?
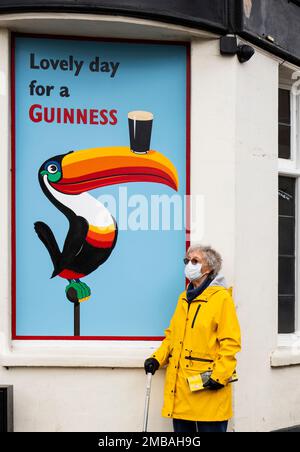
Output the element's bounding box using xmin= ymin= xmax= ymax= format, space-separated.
xmin=0 ymin=14 xmax=300 ymax=431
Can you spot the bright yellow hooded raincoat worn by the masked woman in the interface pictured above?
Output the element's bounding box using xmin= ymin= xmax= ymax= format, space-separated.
xmin=152 ymin=278 xmax=241 ymax=421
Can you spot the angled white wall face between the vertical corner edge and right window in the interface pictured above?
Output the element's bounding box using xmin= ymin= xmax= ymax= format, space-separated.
xmin=235 ymin=47 xmax=300 ymax=431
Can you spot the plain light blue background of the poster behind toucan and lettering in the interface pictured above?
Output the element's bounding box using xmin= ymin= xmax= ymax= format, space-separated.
xmin=15 ymin=36 xmax=187 ymax=336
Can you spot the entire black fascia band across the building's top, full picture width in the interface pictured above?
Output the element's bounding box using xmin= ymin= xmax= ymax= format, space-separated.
xmin=0 ymin=0 xmax=300 ymax=65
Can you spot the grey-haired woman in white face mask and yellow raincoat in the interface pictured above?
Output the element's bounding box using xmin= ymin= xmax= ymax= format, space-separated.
xmin=145 ymin=245 xmax=241 ymax=432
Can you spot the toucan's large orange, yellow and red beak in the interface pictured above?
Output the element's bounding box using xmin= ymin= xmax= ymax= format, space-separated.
xmin=51 ymin=146 xmax=178 ymax=195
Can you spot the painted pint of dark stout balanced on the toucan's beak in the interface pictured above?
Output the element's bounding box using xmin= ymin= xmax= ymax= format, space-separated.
xmin=128 ymin=111 xmax=153 ymax=154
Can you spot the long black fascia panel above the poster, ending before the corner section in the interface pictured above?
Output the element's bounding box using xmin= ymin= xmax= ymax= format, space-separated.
xmin=0 ymin=0 xmax=227 ymax=30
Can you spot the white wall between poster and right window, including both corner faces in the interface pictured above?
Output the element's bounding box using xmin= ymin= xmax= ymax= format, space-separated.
xmin=192 ymin=41 xmax=300 ymax=432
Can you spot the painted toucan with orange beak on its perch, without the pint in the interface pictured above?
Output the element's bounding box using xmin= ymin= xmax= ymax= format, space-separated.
xmin=34 ymin=133 xmax=178 ymax=336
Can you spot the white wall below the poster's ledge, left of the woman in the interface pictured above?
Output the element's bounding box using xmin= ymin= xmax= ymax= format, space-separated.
xmin=0 ymin=368 xmax=171 ymax=432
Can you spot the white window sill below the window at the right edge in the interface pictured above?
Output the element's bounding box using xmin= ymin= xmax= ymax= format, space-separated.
xmin=271 ymin=332 xmax=300 ymax=367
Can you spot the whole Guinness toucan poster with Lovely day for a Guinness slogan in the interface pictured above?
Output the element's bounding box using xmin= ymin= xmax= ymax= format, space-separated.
xmin=12 ymin=35 xmax=189 ymax=340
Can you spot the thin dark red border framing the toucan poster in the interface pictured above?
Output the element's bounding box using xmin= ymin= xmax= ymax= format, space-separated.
xmin=10 ymin=33 xmax=191 ymax=341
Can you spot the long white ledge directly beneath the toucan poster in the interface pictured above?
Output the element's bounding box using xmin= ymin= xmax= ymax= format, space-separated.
xmin=0 ymin=337 xmax=160 ymax=368
